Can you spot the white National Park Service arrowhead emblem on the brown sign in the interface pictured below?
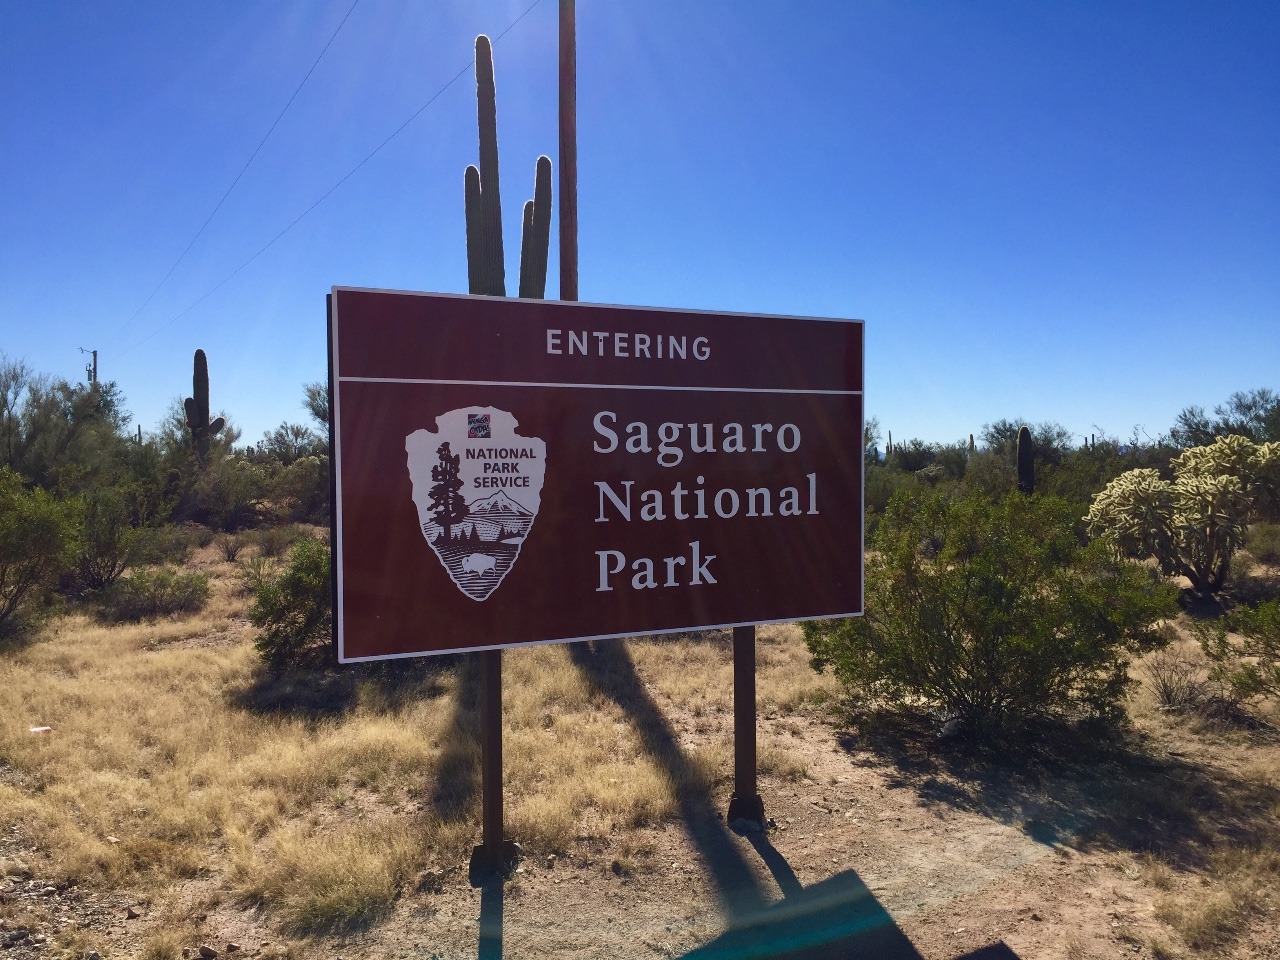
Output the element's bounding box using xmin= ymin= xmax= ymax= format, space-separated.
xmin=404 ymin=407 xmax=547 ymax=600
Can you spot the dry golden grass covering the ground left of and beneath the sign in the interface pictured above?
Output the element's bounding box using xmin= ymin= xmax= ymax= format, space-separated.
xmin=0 ymin=555 xmax=832 ymax=942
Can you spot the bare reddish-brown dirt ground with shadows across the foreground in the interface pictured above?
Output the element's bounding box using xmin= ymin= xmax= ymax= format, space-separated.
xmin=0 ymin=619 xmax=1280 ymax=960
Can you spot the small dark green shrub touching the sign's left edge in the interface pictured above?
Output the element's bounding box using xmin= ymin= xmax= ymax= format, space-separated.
xmin=248 ymin=538 xmax=333 ymax=669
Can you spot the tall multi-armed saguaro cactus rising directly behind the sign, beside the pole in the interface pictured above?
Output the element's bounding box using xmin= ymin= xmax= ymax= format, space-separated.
xmin=462 ymin=35 xmax=552 ymax=300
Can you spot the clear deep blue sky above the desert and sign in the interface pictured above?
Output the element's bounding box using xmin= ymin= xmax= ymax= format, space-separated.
xmin=0 ymin=0 xmax=1280 ymax=442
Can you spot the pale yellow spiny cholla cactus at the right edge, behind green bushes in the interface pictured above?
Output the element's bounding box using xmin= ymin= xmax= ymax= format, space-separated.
xmin=1084 ymin=436 xmax=1280 ymax=596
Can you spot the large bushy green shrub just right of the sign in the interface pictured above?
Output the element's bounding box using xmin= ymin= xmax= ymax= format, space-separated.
xmin=804 ymin=494 xmax=1176 ymax=730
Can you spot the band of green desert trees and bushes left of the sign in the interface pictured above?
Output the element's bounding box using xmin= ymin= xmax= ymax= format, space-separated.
xmin=0 ymin=353 xmax=329 ymax=635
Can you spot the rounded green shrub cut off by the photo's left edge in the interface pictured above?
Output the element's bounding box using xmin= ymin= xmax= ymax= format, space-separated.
xmin=0 ymin=467 xmax=76 ymax=635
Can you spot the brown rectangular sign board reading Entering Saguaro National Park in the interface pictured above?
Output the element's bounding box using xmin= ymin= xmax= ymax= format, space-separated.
xmin=329 ymin=288 xmax=863 ymax=663
